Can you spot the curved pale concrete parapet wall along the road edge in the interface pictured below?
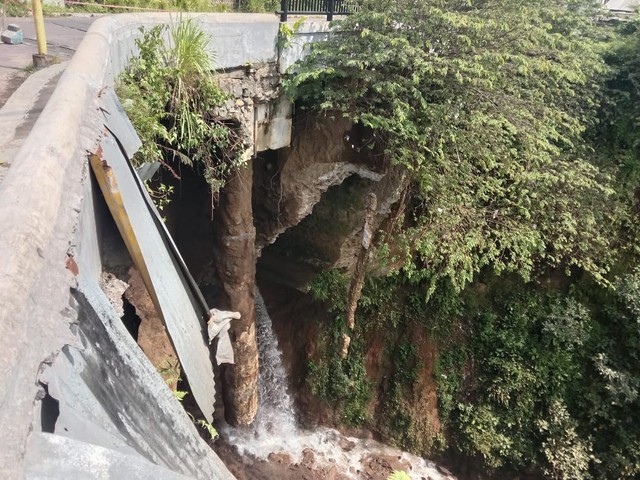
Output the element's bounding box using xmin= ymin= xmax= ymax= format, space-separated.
xmin=0 ymin=14 xmax=328 ymax=478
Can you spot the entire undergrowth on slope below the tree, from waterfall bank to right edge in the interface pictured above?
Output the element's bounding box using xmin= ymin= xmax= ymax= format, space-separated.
xmin=308 ymin=269 xmax=640 ymax=479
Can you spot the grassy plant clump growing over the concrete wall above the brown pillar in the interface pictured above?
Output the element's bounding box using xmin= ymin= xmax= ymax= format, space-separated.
xmin=118 ymin=20 xmax=240 ymax=197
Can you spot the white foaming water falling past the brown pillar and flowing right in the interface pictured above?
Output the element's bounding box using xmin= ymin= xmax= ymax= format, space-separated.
xmin=222 ymin=292 xmax=453 ymax=480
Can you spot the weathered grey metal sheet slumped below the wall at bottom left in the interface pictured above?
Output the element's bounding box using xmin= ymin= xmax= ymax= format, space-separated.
xmin=31 ymin=274 xmax=233 ymax=480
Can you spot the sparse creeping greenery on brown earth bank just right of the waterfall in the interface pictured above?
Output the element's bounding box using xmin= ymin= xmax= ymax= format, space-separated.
xmin=307 ymin=269 xmax=448 ymax=448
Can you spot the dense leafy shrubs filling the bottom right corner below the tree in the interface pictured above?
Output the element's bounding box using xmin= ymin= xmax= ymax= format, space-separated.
xmin=438 ymin=271 xmax=640 ymax=479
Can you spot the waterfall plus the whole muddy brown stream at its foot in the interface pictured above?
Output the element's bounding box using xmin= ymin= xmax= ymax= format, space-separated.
xmin=222 ymin=292 xmax=454 ymax=480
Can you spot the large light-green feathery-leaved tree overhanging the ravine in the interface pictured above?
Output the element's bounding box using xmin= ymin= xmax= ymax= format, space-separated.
xmin=287 ymin=0 xmax=627 ymax=295
